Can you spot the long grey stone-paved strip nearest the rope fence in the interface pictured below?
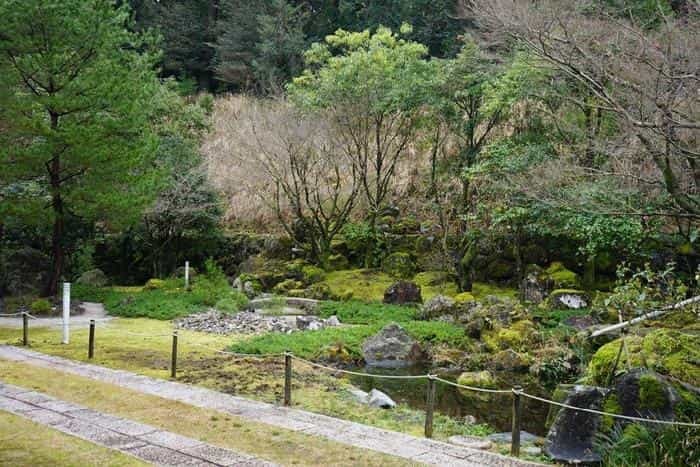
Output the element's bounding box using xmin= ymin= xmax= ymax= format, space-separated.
xmin=0 ymin=345 xmax=540 ymax=467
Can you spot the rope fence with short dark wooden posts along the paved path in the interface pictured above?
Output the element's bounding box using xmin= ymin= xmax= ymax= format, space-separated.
xmin=0 ymin=312 xmax=700 ymax=456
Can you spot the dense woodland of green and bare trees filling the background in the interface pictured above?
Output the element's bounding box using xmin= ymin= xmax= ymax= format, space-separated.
xmin=0 ymin=0 xmax=700 ymax=465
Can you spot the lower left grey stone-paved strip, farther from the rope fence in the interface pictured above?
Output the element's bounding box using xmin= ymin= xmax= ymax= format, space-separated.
xmin=0 ymin=381 xmax=274 ymax=466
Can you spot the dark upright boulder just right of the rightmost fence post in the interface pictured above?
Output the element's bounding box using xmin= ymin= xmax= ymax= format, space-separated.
xmin=544 ymin=385 xmax=607 ymax=464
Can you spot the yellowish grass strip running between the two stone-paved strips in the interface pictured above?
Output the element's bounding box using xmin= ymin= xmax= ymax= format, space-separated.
xmin=0 ymin=360 xmax=411 ymax=466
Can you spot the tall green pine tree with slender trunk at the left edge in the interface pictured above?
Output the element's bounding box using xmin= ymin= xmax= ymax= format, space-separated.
xmin=0 ymin=0 xmax=160 ymax=294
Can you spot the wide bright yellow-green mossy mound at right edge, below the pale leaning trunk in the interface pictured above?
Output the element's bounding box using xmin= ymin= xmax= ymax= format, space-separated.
xmin=586 ymin=329 xmax=700 ymax=385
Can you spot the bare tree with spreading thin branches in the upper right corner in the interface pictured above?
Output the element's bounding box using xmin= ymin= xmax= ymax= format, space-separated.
xmin=465 ymin=0 xmax=700 ymax=220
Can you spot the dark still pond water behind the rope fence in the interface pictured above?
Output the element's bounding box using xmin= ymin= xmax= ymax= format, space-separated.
xmin=350 ymin=366 xmax=548 ymax=436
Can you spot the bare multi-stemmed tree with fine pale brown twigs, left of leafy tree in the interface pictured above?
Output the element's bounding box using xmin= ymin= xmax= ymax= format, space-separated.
xmin=211 ymin=99 xmax=362 ymax=267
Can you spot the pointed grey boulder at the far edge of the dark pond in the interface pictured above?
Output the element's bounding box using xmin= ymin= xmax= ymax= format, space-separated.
xmin=362 ymin=323 xmax=424 ymax=368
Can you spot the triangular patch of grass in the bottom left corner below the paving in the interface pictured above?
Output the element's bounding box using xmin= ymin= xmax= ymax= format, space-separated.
xmin=0 ymin=412 xmax=150 ymax=467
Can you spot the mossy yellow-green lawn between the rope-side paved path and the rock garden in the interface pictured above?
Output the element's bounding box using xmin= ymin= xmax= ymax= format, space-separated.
xmin=0 ymin=318 xmax=487 ymax=439
